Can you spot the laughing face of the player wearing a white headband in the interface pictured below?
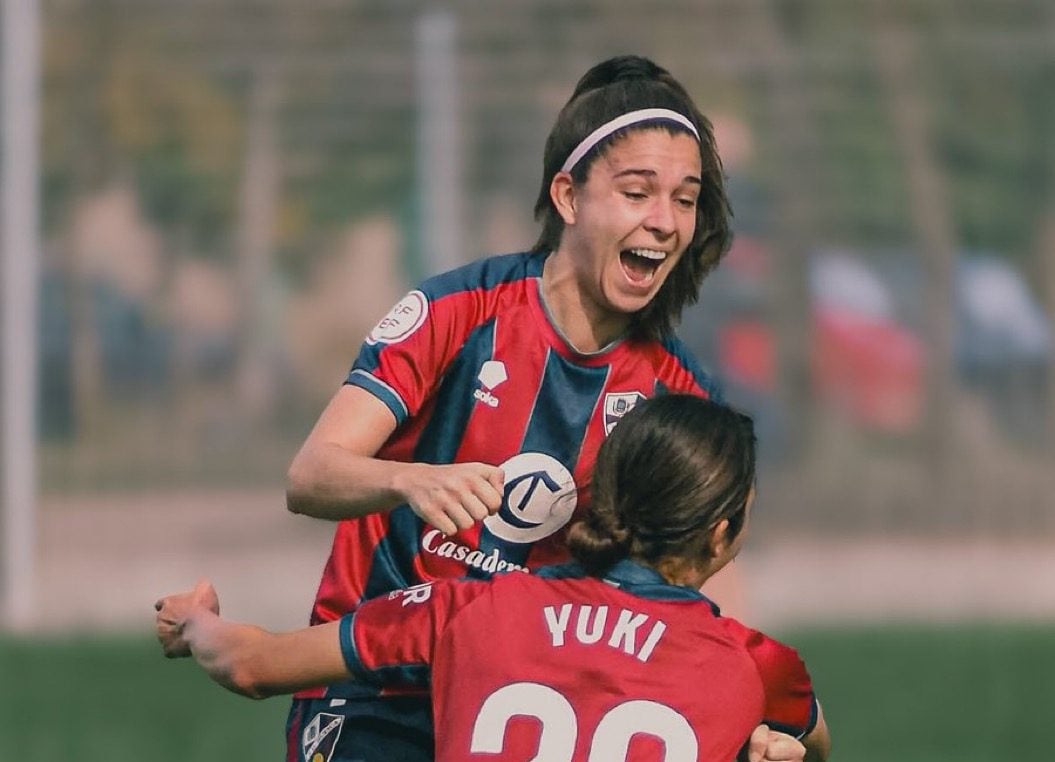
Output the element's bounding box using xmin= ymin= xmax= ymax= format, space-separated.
xmin=551 ymin=129 xmax=701 ymax=319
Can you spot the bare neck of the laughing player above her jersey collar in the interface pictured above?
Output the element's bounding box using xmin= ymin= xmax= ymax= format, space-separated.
xmin=542 ymin=250 xmax=630 ymax=354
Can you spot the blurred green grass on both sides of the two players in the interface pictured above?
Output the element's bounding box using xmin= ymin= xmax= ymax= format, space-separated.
xmin=0 ymin=625 xmax=1055 ymax=762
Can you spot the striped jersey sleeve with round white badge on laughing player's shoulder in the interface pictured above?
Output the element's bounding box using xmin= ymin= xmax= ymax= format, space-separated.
xmin=345 ymin=279 xmax=480 ymax=425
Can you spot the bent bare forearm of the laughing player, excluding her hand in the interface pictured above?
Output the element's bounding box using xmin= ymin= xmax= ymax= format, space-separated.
xmin=286 ymin=443 xmax=415 ymax=520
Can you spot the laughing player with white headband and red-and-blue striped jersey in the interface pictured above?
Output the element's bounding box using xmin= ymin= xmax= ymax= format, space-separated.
xmin=287 ymin=51 xmax=797 ymax=762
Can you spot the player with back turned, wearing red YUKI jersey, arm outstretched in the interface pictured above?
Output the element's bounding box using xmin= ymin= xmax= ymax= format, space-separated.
xmin=156 ymin=395 xmax=830 ymax=762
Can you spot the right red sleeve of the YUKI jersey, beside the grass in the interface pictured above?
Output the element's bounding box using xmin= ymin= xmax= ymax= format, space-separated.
xmin=747 ymin=630 xmax=818 ymax=738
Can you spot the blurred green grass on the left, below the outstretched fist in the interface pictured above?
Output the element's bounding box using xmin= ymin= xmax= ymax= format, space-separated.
xmin=0 ymin=635 xmax=288 ymax=762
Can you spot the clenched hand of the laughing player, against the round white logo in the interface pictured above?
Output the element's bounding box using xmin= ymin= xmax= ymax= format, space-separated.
xmin=394 ymin=463 xmax=505 ymax=535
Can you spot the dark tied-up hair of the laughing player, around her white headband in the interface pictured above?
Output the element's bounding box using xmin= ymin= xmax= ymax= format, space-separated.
xmin=527 ymin=56 xmax=732 ymax=339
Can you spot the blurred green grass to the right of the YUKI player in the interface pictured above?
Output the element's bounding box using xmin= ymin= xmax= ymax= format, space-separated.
xmin=782 ymin=624 xmax=1055 ymax=762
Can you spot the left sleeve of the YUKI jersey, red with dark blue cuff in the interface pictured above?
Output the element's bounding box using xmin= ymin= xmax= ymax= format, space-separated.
xmin=340 ymin=579 xmax=485 ymax=687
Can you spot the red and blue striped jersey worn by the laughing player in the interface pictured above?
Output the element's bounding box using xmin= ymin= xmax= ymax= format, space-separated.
xmin=301 ymin=253 xmax=715 ymax=696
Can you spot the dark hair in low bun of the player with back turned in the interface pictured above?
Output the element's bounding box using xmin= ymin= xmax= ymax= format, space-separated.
xmin=568 ymin=395 xmax=755 ymax=575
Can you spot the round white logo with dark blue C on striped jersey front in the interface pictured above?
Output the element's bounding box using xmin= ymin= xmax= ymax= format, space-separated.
xmin=483 ymin=453 xmax=578 ymax=542
